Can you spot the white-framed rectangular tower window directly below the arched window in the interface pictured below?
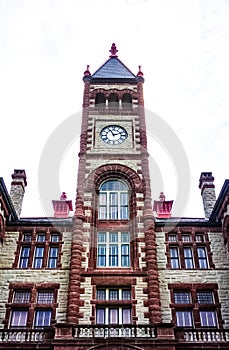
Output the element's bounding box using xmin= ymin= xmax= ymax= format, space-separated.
xmin=97 ymin=232 xmax=130 ymax=267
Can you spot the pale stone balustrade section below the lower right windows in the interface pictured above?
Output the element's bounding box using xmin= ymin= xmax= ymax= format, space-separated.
xmin=175 ymin=328 xmax=229 ymax=343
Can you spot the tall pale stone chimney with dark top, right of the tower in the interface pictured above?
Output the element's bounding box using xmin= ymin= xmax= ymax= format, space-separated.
xmin=199 ymin=172 xmax=216 ymax=219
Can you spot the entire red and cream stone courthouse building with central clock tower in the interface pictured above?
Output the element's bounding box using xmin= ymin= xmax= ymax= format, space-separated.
xmin=0 ymin=44 xmax=229 ymax=350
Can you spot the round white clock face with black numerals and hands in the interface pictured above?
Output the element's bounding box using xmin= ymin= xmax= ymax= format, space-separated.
xmin=100 ymin=125 xmax=128 ymax=145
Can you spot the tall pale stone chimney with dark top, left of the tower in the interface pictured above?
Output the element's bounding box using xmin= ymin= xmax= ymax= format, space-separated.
xmin=10 ymin=169 xmax=27 ymax=217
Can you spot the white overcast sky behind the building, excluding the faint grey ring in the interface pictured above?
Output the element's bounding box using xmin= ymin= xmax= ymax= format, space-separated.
xmin=0 ymin=0 xmax=229 ymax=217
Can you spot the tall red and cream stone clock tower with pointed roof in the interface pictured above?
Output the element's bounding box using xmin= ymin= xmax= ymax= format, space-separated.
xmin=67 ymin=44 xmax=161 ymax=325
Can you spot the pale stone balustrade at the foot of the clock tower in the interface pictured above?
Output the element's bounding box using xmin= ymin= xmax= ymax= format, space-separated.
xmin=73 ymin=325 xmax=156 ymax=338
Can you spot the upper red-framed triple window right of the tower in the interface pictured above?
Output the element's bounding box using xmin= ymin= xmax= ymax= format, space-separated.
xmin=165 ymin=232 xmax=214 ymax=269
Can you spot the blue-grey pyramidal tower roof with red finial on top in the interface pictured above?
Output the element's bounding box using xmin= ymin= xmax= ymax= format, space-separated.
xmin=87 ymin=43 xmax=138 ymax=83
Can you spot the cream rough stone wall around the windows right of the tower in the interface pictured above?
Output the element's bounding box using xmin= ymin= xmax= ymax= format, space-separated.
xmin=157 ymin=232 xmax=229 ymax=328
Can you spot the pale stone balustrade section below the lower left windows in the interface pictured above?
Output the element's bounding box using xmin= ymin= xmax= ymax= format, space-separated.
xmin=0 ymin=328 xmax=54 ymax=343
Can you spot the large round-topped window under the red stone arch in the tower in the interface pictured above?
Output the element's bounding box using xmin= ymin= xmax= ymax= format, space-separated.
xmin=99 ymin=179 xmax=129 ymax=220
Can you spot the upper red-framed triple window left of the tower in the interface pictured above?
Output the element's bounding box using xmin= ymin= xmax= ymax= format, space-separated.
xmin=13 ymin=231 xmax=62 ymax=269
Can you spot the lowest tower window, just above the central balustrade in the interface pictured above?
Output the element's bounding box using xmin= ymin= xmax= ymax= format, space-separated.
xmin=96 ymin=288 xmax=131 ymax=324
